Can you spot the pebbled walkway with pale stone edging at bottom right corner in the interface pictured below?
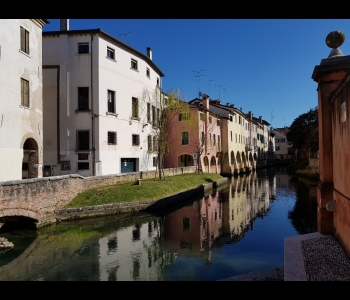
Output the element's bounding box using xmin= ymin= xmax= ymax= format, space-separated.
xmin=221 ymin=232 xmax=350 ymax=281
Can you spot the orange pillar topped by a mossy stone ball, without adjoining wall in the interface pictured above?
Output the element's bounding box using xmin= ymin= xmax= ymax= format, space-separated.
xmin=312 ymin=31 xmax=350 ymax=234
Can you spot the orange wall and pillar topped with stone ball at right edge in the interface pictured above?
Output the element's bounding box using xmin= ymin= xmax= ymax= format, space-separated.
xmin=312 ymin=30 xmax=350 ymax=256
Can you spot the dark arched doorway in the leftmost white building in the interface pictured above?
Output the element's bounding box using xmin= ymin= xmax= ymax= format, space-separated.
xmin=22 ymin=138 xmax=39 ymax=179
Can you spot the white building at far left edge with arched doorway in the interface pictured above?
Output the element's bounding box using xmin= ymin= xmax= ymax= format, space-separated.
xmin=0 ymin=19 xmax=48 ymax=181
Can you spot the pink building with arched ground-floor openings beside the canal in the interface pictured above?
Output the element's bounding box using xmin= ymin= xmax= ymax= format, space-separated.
xmin=164 ymin=94 xmax=221 ymax=174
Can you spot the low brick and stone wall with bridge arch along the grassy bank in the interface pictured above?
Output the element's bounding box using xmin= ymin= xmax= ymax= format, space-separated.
xmin=0 ymin=167 xmax=196 ymax=227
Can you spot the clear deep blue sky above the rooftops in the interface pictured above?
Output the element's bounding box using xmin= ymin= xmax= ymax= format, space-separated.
xmin=44 ymin=19 xmax=350 ymax=128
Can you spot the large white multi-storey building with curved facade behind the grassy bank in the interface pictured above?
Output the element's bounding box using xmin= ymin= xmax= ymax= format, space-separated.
xmin=43 ymin=20 xmax=164 ymax=176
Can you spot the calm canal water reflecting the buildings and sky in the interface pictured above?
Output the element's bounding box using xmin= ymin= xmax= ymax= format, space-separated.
xmin=0 ymin=167 xmax=317 ymax=281
